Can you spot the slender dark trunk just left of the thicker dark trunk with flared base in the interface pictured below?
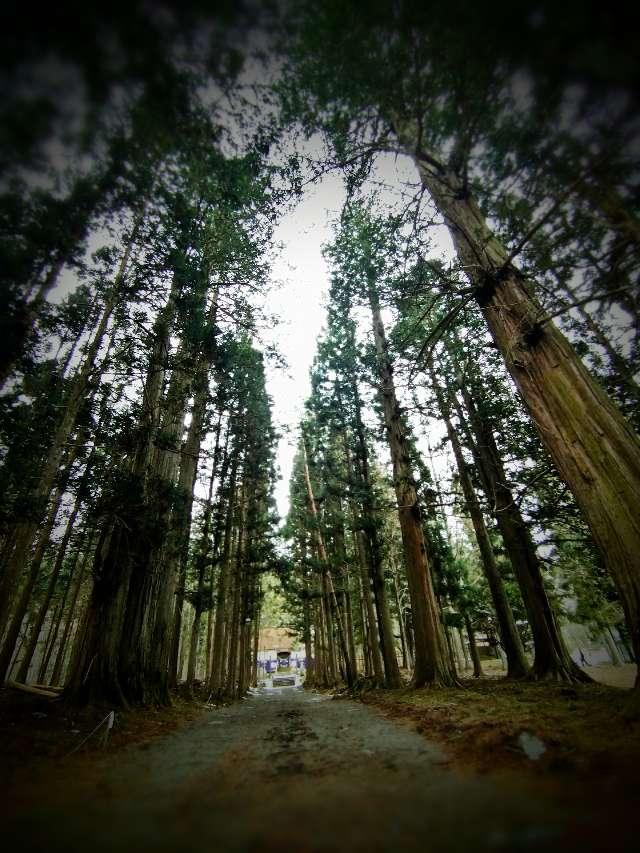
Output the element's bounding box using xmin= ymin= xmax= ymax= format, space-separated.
xmin=431 ymin=369 xmax=529 ymax=678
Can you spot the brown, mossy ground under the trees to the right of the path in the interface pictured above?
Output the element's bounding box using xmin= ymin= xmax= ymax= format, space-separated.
xmin=360 ymin=665 xmax=640 ymax=784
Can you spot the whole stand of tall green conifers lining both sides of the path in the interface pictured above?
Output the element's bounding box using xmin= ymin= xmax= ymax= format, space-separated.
xmin=0 ymin=0 xmax=640 ymax=707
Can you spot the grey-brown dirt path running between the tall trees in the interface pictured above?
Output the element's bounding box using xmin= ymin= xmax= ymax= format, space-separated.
xmin=2 ymin=689 xmax=632 ymax=853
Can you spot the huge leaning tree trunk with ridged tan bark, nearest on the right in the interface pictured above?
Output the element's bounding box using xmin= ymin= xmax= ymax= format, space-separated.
xmin=396 ymin=122 xmax=640 ymax=687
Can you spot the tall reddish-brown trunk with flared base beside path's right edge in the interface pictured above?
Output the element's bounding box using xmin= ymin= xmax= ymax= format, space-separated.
xmin=367 ymin=273 xmax=455 ymax=687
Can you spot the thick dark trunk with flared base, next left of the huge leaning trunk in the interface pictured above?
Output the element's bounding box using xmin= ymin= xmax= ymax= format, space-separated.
xmin=458 ymin=382 xmax=590 ymax=681
